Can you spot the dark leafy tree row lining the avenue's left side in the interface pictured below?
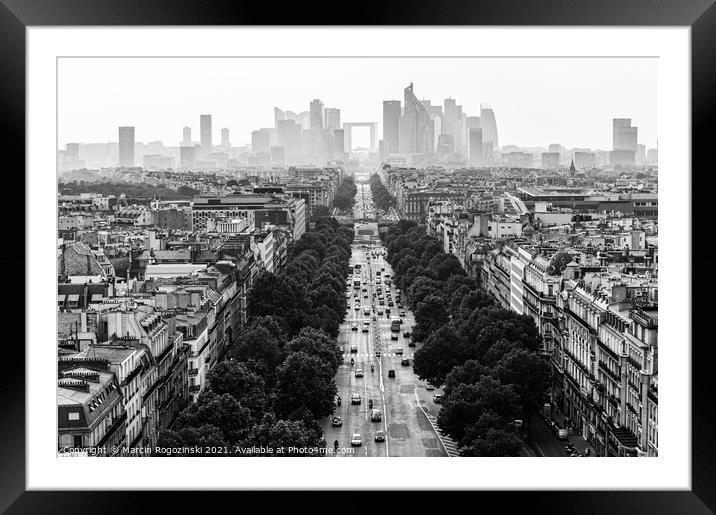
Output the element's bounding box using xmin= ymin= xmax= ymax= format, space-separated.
xmin=159 ymin=218 xmax=353 ymax=456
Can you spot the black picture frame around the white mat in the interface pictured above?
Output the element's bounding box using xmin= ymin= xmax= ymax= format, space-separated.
xmin=0 ymin=0 xmax=716 ymax=514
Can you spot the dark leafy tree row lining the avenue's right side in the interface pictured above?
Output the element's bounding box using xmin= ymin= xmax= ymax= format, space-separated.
xmin=385 ymin=220 xmax=549 ymax=456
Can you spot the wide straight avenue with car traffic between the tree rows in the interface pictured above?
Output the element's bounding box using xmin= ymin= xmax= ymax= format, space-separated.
xmin=321 ymin=180 xmax=447 ymax=457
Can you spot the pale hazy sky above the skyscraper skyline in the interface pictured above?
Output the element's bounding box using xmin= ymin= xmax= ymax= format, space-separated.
xmin=58 ymin=58 xmax=657 ymax=150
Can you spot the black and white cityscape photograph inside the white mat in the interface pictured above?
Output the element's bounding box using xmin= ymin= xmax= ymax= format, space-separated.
xmin=53 ymin=57 xmax=659 ymax=463
